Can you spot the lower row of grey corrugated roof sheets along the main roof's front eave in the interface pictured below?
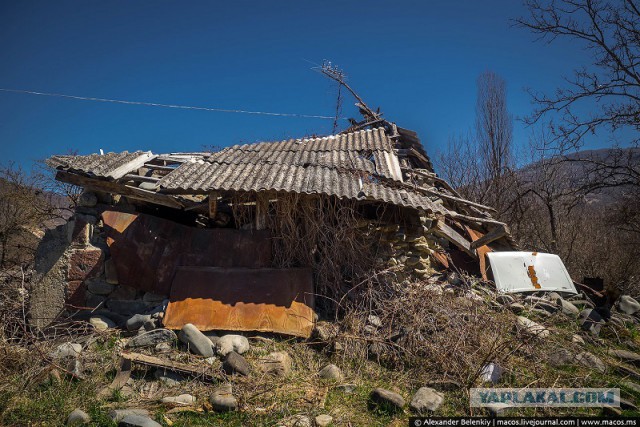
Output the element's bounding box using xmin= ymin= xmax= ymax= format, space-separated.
xmin=159 ymin=162 xmax=448 ymax=214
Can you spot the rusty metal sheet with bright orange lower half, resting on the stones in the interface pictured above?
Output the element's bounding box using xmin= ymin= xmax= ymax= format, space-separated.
xmin=163 ymin=267 xmax=314 ymax=338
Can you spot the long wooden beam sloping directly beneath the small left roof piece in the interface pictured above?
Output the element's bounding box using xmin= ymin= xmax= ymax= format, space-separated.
xmin=56 ymin=171 xmax=184 ymax=209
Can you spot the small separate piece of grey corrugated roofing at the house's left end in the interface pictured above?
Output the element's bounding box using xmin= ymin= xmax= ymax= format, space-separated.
xmin=47 ymin=151 xmax=150 ymax=178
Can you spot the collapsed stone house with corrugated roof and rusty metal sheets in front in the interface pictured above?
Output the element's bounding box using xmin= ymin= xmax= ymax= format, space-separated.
xmin=31 ymin=121 xmax=515 ymax=337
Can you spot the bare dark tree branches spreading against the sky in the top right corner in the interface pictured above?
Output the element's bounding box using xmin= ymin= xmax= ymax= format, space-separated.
xmin=515 ymin=0 xmax=640 ymax=147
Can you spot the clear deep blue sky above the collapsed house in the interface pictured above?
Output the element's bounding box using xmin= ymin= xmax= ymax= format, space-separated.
xmin=0 ymin=0 xmax=590 ymax=170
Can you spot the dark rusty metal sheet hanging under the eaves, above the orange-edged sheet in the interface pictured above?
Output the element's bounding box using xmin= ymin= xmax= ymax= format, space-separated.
xmin=102 ymin=210 xmax=271 ymax=295
